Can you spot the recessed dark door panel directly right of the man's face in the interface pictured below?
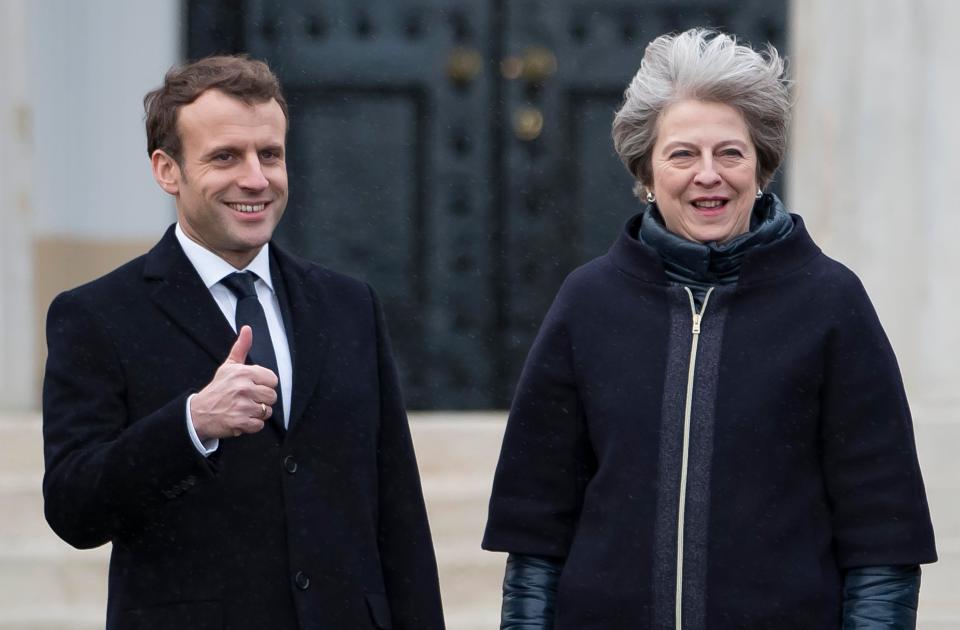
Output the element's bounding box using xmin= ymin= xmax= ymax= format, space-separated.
xmin=278 ymin=90 xmax=427 ymax=390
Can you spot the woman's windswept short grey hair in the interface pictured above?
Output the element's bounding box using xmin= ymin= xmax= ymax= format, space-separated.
xmin=613 ymin=28 xmax=790 ymax=198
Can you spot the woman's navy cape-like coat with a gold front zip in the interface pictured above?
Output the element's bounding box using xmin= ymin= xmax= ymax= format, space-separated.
xmin=484 ymin=217 xmax=936 ymax=630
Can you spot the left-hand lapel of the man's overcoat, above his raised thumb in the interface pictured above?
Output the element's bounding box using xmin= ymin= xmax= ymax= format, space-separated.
xmin=143 ymin=226 xmax=234 ymax=364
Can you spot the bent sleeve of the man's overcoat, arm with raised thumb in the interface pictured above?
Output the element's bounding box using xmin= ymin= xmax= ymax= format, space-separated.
xmin=43 ymin=291 xmax=213 ymax=548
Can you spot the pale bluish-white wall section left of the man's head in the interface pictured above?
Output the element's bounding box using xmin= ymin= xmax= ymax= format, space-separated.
xmin=27 ymin=0 xmax=183 ymax=240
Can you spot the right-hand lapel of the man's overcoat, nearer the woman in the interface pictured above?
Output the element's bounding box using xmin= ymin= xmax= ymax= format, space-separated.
xmin=270 ymin=243 xmax=329 ymax=432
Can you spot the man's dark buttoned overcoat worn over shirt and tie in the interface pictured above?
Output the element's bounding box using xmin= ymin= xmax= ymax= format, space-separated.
xmin=43 ymin=228 xmax=443 ymax=630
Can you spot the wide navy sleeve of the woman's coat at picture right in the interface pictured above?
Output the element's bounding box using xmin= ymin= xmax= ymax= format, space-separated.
xmin=821 ymin=274 xmax=937 ymax=569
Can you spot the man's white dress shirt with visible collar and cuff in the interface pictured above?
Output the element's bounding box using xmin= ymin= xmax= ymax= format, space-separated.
xmin=174 ymin=223 xmax=293 ymax=455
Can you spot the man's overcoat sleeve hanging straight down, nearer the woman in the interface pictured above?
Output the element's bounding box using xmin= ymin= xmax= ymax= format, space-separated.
xmin=371 ymin=289 xmax=444 ymax=630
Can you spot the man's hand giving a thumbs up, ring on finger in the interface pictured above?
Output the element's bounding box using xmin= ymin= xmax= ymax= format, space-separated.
xmin=190 ymin=326 xmax=279 ymax=441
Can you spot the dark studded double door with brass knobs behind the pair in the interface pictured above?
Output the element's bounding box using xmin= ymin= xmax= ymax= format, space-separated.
xmin=188 ymin=0 xmax=786 ymax=409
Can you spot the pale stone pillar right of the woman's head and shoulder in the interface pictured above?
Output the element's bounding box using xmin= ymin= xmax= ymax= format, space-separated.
xmin=788 ymin=0 xmax=960 ymax=422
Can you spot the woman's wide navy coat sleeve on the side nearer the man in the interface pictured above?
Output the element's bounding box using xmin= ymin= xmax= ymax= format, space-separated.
xmin=483 ymin=289 xmax=596 ymax=558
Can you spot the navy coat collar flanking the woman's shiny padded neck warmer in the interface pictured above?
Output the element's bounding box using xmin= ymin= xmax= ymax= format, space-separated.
xmin=607 ymin=213 xmax=820 ymax=288
